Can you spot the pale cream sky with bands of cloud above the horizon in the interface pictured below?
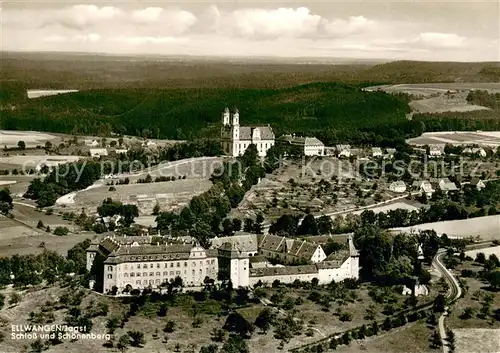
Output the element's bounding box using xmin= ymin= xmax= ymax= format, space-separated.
xmin=0 ymin=0 xmax=500 ymax=61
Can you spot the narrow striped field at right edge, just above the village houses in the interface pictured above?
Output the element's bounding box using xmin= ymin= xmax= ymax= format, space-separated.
xmin=407 ymin=131 xmax=500 ymax=147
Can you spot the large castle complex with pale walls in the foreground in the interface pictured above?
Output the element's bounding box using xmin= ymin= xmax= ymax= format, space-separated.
xmin=87 ymin=234 xmax=359 ymax=294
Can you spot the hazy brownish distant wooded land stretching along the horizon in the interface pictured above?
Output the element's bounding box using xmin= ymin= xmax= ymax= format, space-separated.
xmin=0 ymin=52 xmax=500 ymax=89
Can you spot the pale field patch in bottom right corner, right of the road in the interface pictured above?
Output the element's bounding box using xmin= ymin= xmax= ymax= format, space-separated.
xmin=453 ymin=329 xmax=500 ymax=353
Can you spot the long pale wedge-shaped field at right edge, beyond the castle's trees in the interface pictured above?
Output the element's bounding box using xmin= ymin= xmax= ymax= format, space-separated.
xmin=397 ymin=215 xmax=500 ymax=240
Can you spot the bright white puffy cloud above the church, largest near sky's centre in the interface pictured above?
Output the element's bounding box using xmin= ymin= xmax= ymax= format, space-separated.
xmin=225 ymin=7 xmax=321 ymax=38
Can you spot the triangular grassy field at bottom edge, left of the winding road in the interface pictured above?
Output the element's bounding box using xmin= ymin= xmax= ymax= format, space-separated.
xmin=336 ymin=321 xmax=441 ymax=353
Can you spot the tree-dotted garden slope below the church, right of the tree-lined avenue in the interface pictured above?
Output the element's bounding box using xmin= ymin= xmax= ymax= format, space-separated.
xmin=231 ymin=159 xmax=400 ymax=221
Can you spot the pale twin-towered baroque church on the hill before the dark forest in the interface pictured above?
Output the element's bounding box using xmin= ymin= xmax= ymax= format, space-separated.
xmin=221 ymin=107 xmax=274 ymax=157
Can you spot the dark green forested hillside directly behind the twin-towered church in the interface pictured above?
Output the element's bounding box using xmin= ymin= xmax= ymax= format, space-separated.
xmin=1 ymin=83 xmax=408 ymax=143
